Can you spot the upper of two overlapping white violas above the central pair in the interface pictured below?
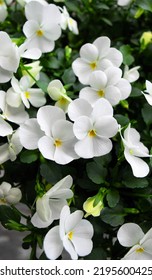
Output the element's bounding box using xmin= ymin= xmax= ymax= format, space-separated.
xmin=72 ymin=36 xmax=123 ymax=85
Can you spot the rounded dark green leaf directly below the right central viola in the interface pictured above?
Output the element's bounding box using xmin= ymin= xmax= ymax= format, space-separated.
xmin=86 ymin=162 xmax=107 ymax=184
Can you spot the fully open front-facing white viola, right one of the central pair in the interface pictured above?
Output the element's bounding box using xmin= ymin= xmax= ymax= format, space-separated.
xmin=68 ymin=99 xmax=118 ymax=158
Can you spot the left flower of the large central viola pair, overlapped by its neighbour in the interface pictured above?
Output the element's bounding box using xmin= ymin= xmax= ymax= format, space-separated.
xmin=37 ymin=105 xmax=78 ymax=164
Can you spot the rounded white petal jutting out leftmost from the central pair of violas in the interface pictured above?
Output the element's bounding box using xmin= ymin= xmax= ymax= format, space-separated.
xmin=19 ymin=118 xmax=44 ymax=150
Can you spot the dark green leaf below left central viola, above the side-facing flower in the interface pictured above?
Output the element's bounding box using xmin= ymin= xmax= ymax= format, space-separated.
xmin=40 ymin=162 xmax=62 ymax=185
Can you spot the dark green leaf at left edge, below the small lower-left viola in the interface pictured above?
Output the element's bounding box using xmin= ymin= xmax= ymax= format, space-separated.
xmin=0 ymin=205 xmax=21 ymax=226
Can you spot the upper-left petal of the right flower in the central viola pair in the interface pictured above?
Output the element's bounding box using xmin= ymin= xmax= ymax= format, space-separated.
xmin=68 ymin=98 xmax=92 ymax=121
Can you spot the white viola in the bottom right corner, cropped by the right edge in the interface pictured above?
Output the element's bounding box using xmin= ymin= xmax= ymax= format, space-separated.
xmin=117 ymin=223 xmax=152 ymax=260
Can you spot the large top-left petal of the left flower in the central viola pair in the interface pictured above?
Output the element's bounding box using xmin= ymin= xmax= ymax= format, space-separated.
xmin=37 ymin=105 xmax=65 ymax=136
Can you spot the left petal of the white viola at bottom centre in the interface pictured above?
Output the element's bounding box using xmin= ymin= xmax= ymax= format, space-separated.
xmin=43 ymin=226 xmax=63 ymax=260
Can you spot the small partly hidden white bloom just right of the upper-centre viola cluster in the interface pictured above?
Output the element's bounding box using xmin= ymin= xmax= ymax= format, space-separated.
xmin=123 ymin=65 xmax=140 ymax=83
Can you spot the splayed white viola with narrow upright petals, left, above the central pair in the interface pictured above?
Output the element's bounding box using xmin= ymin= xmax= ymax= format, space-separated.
xmin=6 ymin=76 xmax=46 ymax=108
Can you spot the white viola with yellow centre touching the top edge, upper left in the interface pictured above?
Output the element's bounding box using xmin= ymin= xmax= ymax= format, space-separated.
xmin=23 ymin=1 xmax=61 ymax=53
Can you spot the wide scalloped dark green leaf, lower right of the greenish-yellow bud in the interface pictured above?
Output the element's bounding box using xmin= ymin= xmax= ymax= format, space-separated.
xmin=100 ymin=206 xmax=126 ymax=227
